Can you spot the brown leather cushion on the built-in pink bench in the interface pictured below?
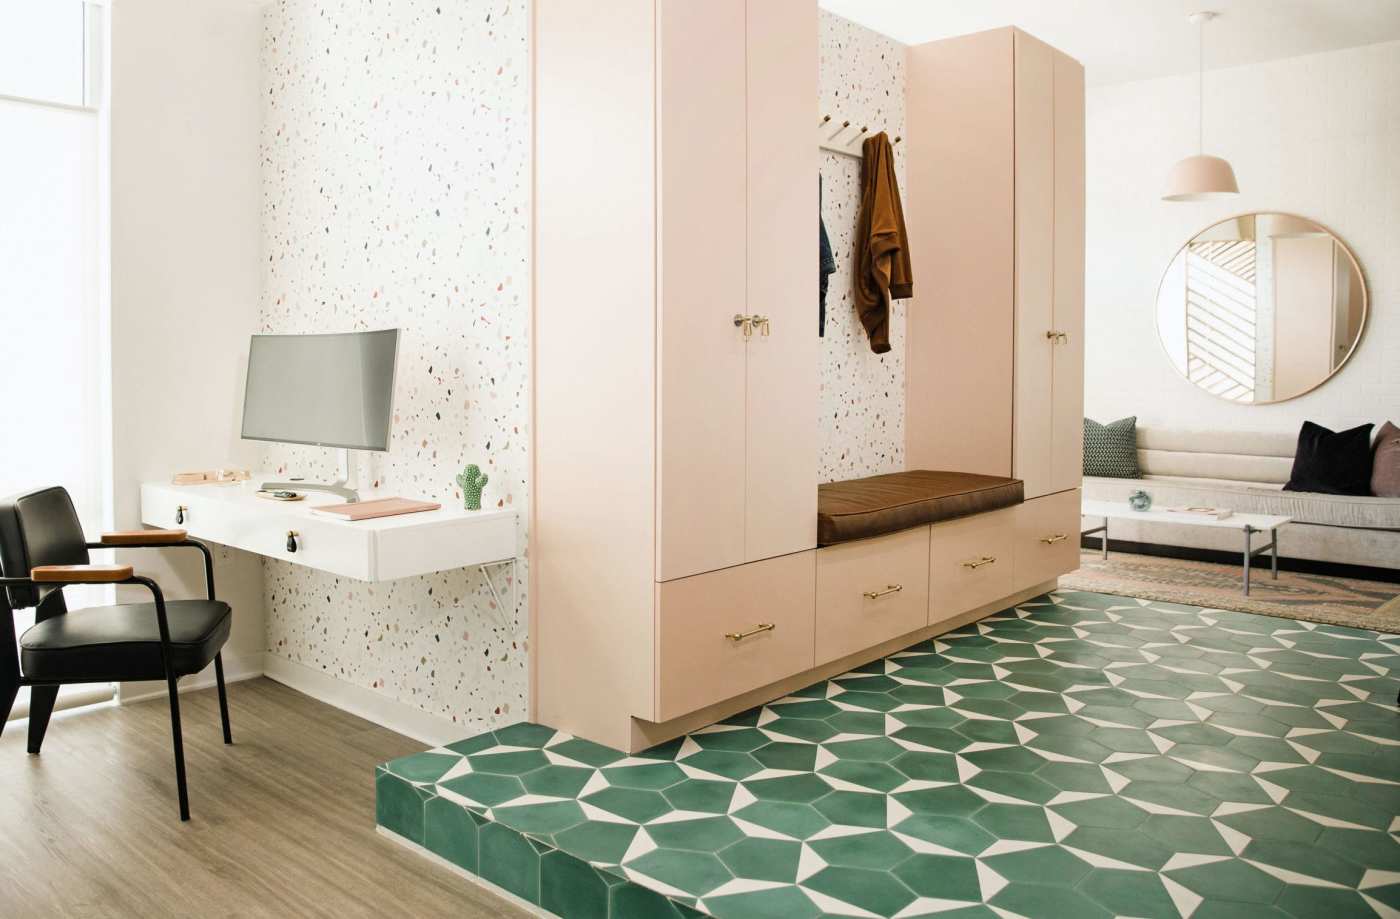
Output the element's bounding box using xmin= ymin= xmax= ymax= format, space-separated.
xmin=816 ymin=469 xmax=1025 ymax=545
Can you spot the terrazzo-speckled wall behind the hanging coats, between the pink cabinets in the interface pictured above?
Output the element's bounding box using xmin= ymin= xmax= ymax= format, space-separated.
xmin=818 ymin=10 xmax=920 ymax=482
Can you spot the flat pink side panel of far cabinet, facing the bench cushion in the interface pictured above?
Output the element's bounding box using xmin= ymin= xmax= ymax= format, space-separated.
xmin=900 ymin=28 xmax=1015 ymax=475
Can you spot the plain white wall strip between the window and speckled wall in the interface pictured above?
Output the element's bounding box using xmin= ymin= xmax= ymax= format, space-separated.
xmin=111 ymin=0 xmax=263 ymax=698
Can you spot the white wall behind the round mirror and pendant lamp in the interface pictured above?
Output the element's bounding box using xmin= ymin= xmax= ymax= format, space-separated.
xmin=1085 ymin=42 xmax=1400 ymax=431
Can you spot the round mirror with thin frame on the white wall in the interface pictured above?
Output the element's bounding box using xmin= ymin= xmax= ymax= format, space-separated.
xmin=1156 ymin=213 xmax=1366 ymax=405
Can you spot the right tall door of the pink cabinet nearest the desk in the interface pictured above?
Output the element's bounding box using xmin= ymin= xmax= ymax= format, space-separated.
xmin=744 ymin=0 xmax=819 ymax=560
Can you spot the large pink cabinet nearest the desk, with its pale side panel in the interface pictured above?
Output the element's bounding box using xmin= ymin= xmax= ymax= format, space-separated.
xmin=531 ymin=0 xmax=818 ymax=748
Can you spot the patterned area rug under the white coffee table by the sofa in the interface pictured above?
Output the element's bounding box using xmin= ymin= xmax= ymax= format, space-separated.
xmin=1060 ymin=549 xmax=1400 ymax=635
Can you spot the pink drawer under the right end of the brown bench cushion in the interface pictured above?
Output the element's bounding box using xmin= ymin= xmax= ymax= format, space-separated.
xmin=928 ymin=507 xmax=1015 ymax=625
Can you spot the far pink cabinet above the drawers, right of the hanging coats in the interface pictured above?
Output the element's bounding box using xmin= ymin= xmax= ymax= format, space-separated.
xmin=904 ymin=28 xmax=1084 ymax=499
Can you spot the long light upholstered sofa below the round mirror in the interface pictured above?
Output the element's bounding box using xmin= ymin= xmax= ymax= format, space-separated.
xmin=1084 ymin=427 xmax=1400 ymax=569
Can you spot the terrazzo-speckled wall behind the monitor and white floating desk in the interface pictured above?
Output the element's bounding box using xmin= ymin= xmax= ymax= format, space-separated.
xmin=259 ymin=0 xmax=529 ymax=727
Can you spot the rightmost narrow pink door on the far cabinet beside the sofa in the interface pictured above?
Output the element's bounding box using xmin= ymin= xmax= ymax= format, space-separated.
xmin=1052 ymin=52 xmax=1084 ymax=495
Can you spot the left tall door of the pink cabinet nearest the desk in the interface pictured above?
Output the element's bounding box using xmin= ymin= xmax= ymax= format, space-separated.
xmin=655 ymin=0 xmax=756 ymax=580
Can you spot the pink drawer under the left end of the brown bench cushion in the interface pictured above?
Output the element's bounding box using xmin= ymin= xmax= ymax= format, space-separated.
xmin=816 ymin=527 xmax=928 ymax=664
